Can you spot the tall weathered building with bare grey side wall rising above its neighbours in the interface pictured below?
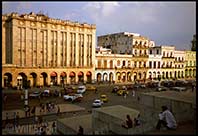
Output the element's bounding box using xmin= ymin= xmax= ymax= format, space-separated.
xmin=97 ymin=32 xmax=155 ymax=82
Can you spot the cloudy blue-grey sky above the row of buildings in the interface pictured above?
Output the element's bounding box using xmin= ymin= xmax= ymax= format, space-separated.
xmin=2 ymin=1 xmax=196 ymax=50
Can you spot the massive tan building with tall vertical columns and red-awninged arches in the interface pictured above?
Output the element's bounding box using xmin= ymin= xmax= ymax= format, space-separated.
xmin=2 ymin=13 xmax=96 ymax=87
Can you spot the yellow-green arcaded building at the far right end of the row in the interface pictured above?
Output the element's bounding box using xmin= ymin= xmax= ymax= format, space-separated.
xmin=185 ymin=51 xmax=196 ymax=79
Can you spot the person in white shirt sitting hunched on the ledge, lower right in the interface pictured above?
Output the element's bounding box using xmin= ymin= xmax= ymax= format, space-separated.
xmin=156 ymin=106 xmax=177 ymax=130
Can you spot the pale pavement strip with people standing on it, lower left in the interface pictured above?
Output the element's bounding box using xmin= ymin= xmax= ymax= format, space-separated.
xmin=2 ymin=104 xmax=85 ymax=120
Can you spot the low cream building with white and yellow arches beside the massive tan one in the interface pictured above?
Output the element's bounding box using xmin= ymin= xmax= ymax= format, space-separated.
xmin=95 ymin=47 xmax=133 ymax=83
